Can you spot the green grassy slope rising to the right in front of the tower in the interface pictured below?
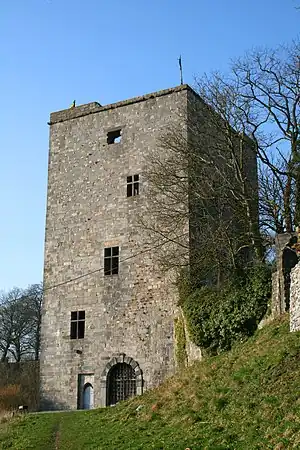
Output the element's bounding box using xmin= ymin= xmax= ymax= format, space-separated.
xmin=0 ymin=318 xmax=300 ymax=450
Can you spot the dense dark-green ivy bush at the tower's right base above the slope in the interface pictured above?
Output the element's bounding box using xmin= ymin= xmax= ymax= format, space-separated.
xmin=181 ymin=265 xmax=271 ymax=354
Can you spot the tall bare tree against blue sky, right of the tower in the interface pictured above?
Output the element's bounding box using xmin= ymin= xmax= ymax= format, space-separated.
xmin=229 ymin=41 xmax=300 ymax=232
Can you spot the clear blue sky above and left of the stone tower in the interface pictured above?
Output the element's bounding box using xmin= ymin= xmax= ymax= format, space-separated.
xmin=0 ymin=0 xmax=300 ymax=290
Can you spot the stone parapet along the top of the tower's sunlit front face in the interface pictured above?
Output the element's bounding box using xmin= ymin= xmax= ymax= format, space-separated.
xmin=49 ymin=84 xmax=194 ymax=125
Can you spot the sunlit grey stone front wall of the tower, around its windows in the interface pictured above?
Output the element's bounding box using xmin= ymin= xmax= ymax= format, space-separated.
xmin=40 ymin=85 xmax=195 ymax=409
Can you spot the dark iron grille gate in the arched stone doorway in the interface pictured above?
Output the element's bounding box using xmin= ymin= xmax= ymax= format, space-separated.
xmin=107 ymin=363 xmax=136 ymax=406
